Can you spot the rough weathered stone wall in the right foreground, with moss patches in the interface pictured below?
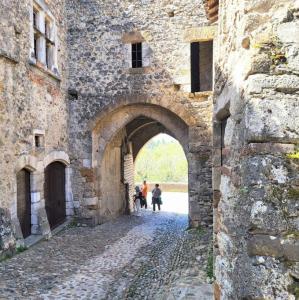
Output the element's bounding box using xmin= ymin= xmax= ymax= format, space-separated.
xmin=214 ymin=0 xmax=299 ymax=299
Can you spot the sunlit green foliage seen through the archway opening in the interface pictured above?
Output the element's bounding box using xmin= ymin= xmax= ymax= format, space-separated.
xmin=135 ymin=138 xmax=188 ymax=183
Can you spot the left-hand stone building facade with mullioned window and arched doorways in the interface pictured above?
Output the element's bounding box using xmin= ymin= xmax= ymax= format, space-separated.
xmin=0 ymin=0 xmax=73 ymax=256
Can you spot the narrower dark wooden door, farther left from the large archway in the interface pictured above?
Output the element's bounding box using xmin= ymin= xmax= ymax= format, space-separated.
xmin=17 ymin=169 xmax=31 ymax=238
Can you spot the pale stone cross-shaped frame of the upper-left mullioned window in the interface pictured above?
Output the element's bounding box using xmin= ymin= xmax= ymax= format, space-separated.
xmin=30 ymin=0 xmax=59 ymax=75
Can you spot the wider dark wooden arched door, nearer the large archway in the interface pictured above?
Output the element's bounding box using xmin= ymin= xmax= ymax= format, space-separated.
xmin=45 ymin=162 xmax=66 ymax=229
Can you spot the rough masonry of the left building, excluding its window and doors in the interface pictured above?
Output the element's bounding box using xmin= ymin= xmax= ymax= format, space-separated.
xmin=0 ymin=0 xmax=68 ymax=255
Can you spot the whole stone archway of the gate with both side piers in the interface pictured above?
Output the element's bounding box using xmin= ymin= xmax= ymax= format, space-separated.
xmin=75 ymin=103 xmax=212 ymax=226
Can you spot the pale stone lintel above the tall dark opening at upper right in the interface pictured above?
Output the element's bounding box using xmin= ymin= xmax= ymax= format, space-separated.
xmin=184 ymin=26 xmax=217 ymax=43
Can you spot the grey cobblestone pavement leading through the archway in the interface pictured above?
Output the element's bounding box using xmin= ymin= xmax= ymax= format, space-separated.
xmin=0 ymin=211 xmax=213 ymax=300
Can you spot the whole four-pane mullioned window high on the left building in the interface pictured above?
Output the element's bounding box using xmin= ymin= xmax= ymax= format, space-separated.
xmin=31 ymin=0 xmax=58 ymax=73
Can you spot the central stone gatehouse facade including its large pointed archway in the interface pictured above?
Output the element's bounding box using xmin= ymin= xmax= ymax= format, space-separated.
xmin=67 ymin=1 xmax=215 ymax=225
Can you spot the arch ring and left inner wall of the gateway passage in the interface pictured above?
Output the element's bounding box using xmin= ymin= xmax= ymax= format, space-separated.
xmin=93 ymin=104 xmax=188 ymax=219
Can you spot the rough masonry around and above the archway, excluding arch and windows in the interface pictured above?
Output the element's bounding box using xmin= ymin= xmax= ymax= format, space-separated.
xmin=67 ymin=0 xmax=213 ymax=225
